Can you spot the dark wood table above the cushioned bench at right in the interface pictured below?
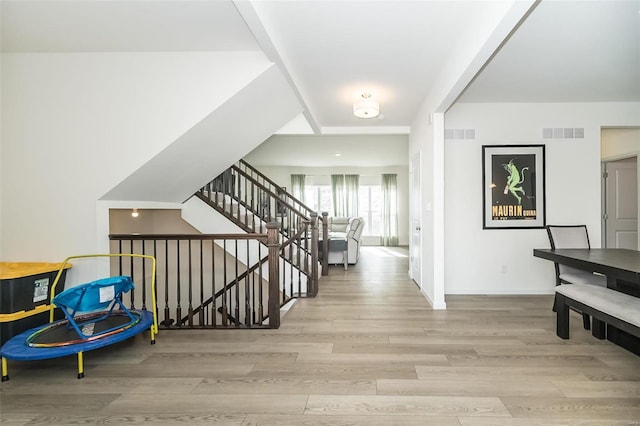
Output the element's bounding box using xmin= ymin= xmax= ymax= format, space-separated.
xmin=533 ymin=249 xmax=640 ymax=355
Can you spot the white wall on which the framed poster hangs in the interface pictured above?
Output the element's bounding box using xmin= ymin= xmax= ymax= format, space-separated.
xmin=445 ymin=103 xmax=640 ymax=294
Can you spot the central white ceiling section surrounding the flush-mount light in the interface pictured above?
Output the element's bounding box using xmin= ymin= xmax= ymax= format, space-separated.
xmin=249 ymin=0 xmax=484 ymax=131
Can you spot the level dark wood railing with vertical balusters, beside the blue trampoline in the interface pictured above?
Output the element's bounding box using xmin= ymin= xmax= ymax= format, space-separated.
xmin=109 ymin=224 xmax=282 ymax=329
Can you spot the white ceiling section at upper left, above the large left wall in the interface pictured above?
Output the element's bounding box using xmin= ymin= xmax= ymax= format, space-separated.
xmin=0 ymin=0 xmax=260 ymax=52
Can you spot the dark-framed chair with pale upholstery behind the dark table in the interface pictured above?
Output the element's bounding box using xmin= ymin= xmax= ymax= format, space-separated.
xmin=547 ymin=225 xmax=607 ymax=330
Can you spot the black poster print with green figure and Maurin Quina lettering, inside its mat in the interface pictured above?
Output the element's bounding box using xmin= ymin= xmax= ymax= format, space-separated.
xmin=491 ymin=154 xmax=537 ymax=220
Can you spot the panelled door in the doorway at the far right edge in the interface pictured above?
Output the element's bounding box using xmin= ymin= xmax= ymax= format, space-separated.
xmin=604 ymin=157 xmax=638 ymax=250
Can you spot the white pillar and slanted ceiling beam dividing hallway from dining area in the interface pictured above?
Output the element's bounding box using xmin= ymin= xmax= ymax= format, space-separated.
xmin=409 ymin=0 xmax=535 ymax=309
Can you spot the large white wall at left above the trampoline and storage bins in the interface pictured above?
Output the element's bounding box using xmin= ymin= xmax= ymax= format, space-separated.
xmin=0 ymin=52 xmax=270 ymax=261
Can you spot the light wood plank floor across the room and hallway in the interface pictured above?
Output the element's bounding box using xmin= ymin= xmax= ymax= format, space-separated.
xmin=0 ymin=248 xmax=640 ymax=426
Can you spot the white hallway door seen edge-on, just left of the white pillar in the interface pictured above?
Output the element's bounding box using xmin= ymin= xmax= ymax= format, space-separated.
xmin=409 ymin=151 xmax=422 ymax=288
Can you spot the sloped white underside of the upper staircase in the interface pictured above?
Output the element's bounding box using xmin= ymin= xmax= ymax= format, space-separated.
xmin=102 ymin=66 xmax=302 ymax=202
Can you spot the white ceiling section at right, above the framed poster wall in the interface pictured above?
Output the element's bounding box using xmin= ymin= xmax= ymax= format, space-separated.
xmin=459 ymin=0 xmax=640 ymax=102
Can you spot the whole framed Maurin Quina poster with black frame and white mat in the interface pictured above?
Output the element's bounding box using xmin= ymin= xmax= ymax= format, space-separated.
xmin=482 ymin=145 xmax=546 ymax=229
